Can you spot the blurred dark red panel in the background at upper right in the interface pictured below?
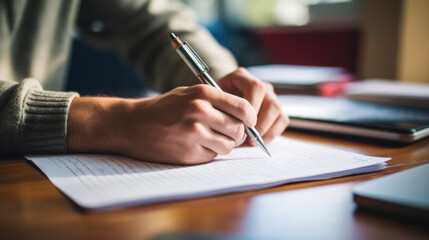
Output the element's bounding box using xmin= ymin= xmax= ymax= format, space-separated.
xmin=255 ymin=27 xmax=360 ymax=74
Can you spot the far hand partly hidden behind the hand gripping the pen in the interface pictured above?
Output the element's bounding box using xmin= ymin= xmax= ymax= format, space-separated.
xmin=218 ymin=68 xmax=289 ymax=145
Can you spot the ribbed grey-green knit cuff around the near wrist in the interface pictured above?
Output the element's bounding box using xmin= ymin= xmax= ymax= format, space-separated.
xmin=20 ymin=90 xmax=78 ymax=153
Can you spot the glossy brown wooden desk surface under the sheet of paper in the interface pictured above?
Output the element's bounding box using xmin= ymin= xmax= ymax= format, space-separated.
xmin=0 ymin=132 xmax=429 ymax=240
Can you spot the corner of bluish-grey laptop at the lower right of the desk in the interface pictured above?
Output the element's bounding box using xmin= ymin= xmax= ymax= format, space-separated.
xmin=353 ymin=164 xmax=429 ymax=221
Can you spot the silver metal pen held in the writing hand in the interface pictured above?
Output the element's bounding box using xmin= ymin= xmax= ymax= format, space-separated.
xmin=169 ymin=33 xmax=271 ymax=157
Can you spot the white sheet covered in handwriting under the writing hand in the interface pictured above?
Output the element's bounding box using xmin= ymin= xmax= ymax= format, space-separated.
xmin=26 ymin=137 xmax=389 ymax=209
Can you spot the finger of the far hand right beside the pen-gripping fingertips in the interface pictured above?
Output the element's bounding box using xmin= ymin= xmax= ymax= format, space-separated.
xmin=256 ymin=94 xmax=281 ymax=137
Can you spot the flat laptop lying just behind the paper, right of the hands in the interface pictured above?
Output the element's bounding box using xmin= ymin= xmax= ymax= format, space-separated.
xmin=279 ymin=95 xmax=429 ymax=143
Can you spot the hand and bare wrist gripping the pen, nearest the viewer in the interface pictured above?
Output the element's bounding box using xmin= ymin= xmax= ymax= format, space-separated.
xmin=68 ymin=85 xmax=256 ymax=164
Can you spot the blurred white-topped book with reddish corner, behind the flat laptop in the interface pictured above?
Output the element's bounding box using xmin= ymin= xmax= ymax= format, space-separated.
xmin=247 ymin=64 xmax=353 ymax=97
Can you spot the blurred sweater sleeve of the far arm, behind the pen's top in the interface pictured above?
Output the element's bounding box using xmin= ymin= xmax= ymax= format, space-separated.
xmin=78 ymin=0 xmax=237 ymax=92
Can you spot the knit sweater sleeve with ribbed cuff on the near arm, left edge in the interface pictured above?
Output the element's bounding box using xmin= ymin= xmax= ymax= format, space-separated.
xmin=0 ymin=79 xmax=78 ymax=155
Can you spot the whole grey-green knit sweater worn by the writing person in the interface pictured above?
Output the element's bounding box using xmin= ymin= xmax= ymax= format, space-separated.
xmin=0 ymin=0 xmax=236 ymax=155
